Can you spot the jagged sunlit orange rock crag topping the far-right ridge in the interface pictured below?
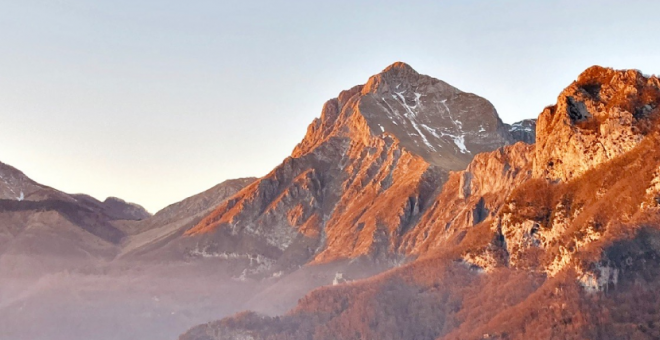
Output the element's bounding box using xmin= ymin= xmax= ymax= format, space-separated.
xmin=534 ymin=66 xmax=660 ymax=181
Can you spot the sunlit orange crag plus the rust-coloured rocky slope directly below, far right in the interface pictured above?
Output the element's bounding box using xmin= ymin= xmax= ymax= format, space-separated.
xmin=493 ymin=67 xmax=660 ymax=282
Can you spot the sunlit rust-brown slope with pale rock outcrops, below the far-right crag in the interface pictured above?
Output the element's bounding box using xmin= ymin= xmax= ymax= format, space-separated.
xmin=497 ymin=128 xmax=660 ymax=276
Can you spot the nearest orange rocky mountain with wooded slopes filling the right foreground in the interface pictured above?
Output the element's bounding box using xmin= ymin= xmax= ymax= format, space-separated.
xmin=180 ymin=67 xmax=660 ymax=340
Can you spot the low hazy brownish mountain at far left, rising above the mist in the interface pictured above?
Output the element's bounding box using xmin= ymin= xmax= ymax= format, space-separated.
xmin=0 ymin=163 xmax=149 ymax=281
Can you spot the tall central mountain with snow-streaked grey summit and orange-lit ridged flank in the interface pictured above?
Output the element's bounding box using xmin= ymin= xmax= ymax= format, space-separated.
xmin=182 ymin=63 xmax=514 ymax=267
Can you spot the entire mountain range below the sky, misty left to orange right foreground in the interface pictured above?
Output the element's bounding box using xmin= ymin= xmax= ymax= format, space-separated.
xmin=0 ymin=62 xmax=660 ymax=340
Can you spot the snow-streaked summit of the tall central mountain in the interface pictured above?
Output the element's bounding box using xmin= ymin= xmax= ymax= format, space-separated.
xmin=292 ymin=62 xmax=513 ymax=170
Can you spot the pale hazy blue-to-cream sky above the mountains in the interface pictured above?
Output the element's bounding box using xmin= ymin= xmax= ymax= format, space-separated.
xmin=0 ymin=0 xmax=660 ymax=212
